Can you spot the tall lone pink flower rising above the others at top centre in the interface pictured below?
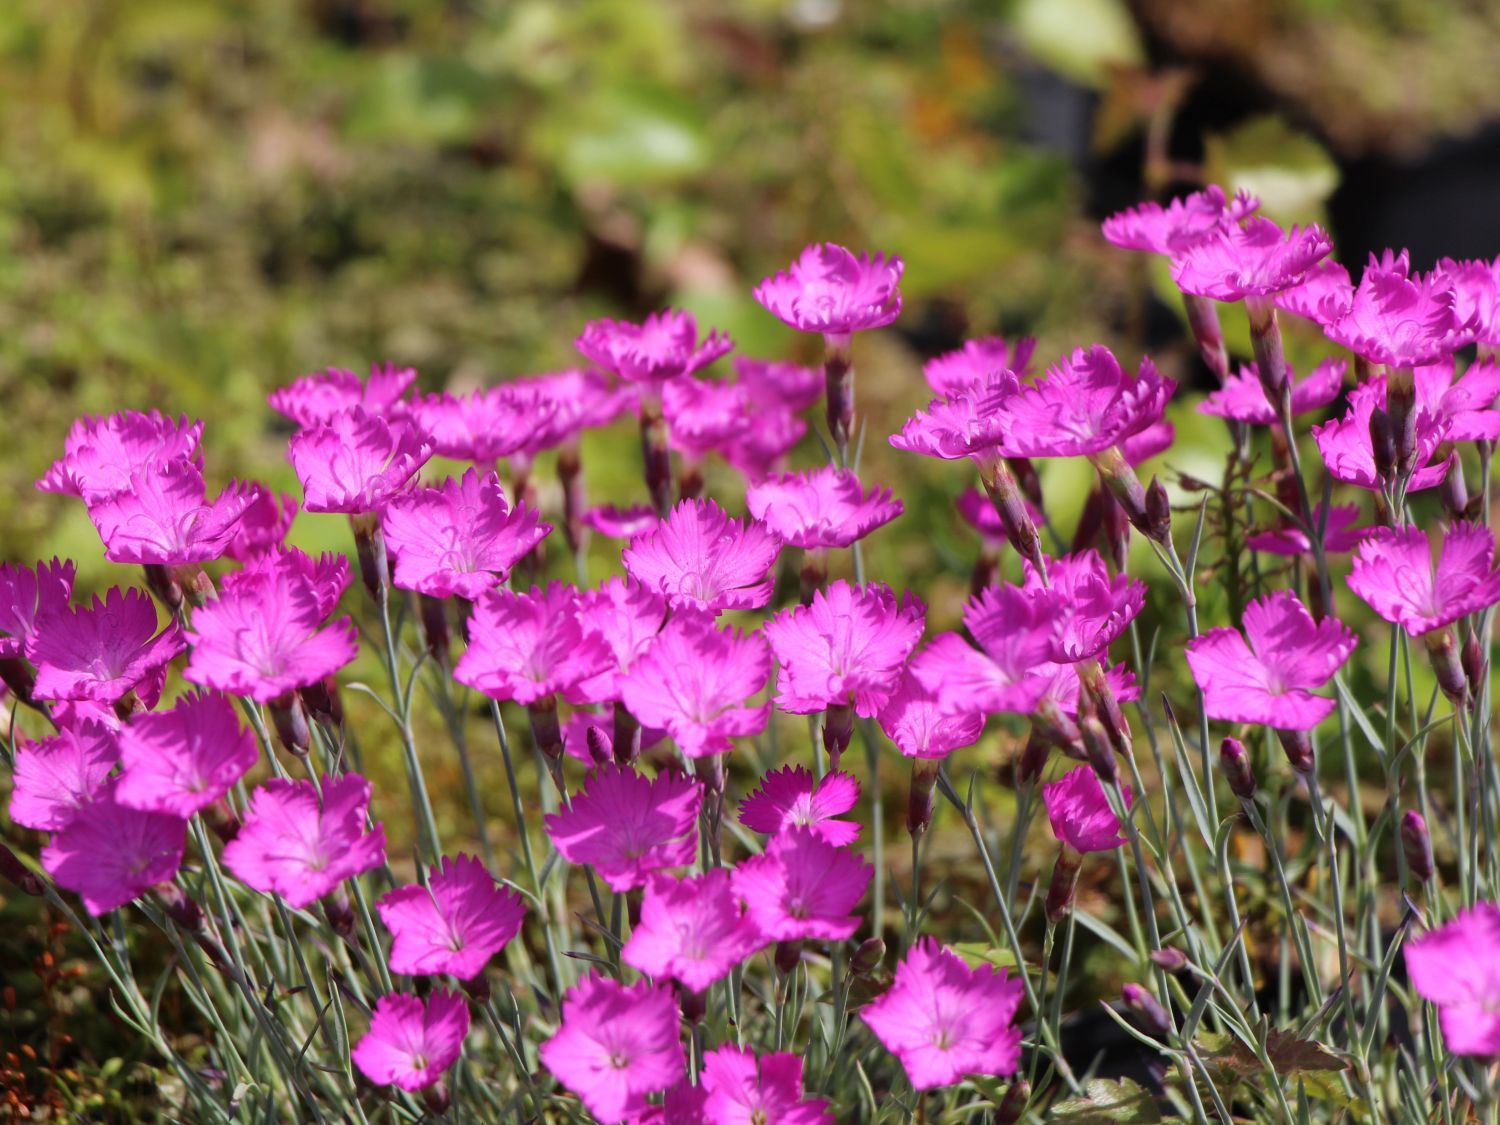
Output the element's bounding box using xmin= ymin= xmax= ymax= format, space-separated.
xmin=755 ymin=243 xmax=903 ymax=336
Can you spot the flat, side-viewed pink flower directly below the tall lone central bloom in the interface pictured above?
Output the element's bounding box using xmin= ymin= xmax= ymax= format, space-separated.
xmin=746 ymin=465 xmax=902 ymax=551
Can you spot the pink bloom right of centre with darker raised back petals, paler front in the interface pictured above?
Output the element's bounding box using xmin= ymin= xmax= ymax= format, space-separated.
xmin=912 ymin=585 xmax=1061 ymax=714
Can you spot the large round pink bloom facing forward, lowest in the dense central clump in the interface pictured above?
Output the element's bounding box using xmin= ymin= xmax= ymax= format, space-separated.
xmin=617 ymin=614 xmax=771 ymax=758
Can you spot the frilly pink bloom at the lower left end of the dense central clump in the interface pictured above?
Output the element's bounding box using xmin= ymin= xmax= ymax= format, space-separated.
xmin=453 ymin=582 xmax=612 ymax=704
